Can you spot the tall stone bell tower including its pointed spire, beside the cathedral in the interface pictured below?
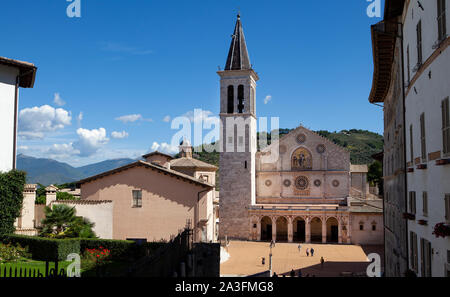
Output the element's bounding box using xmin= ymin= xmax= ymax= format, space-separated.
xmin=218 ymin=15 xmax=259 ymax=240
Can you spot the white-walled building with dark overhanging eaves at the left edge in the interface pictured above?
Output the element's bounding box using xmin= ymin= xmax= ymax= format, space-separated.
xmin=0 ymin=57 xmax=37 ymax=172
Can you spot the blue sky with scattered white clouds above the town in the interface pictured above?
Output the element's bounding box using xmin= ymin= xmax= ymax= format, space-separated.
xmin=0 ymin=0 xmax=383 ymax=166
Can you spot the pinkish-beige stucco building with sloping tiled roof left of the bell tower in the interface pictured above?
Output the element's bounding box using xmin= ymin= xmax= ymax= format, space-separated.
xmin=73 ymin=141 xmax=217 ymax=242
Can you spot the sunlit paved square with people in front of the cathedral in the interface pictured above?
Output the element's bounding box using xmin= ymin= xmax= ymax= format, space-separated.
xmin=220 ymin=241 xmax=383 ymax=277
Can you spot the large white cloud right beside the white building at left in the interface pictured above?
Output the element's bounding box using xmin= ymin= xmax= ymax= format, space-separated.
xmin=19 ymin=105 xmax=72 ymax=139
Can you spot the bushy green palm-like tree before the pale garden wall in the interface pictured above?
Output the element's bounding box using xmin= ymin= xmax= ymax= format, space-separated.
xmin=40 ymin=204 xmax=95 ymax=238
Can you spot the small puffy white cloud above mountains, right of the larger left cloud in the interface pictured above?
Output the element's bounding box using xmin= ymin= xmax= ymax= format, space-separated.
xmin=73 ymin=128 xmax=109 ymax=157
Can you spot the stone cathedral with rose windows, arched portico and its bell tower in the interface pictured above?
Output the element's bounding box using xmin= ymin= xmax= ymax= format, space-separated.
xmin=218 ymin=16 xmax=383 ymax=244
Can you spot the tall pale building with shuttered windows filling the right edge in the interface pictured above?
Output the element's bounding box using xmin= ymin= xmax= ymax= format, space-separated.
xmin=370 ymin=0 xmax=450 ymax=276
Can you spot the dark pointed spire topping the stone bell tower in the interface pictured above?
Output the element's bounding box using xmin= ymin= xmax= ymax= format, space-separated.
xmin=225 ymin=14 xmax=252 ymax=70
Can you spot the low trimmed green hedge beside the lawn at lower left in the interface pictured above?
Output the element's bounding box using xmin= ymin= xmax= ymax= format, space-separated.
xmin=2 ymin=234 xmax=80 ymax=261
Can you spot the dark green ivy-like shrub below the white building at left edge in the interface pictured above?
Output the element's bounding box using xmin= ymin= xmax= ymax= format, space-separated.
xmin=0 ymin=170 xmax=25 ymax=236
